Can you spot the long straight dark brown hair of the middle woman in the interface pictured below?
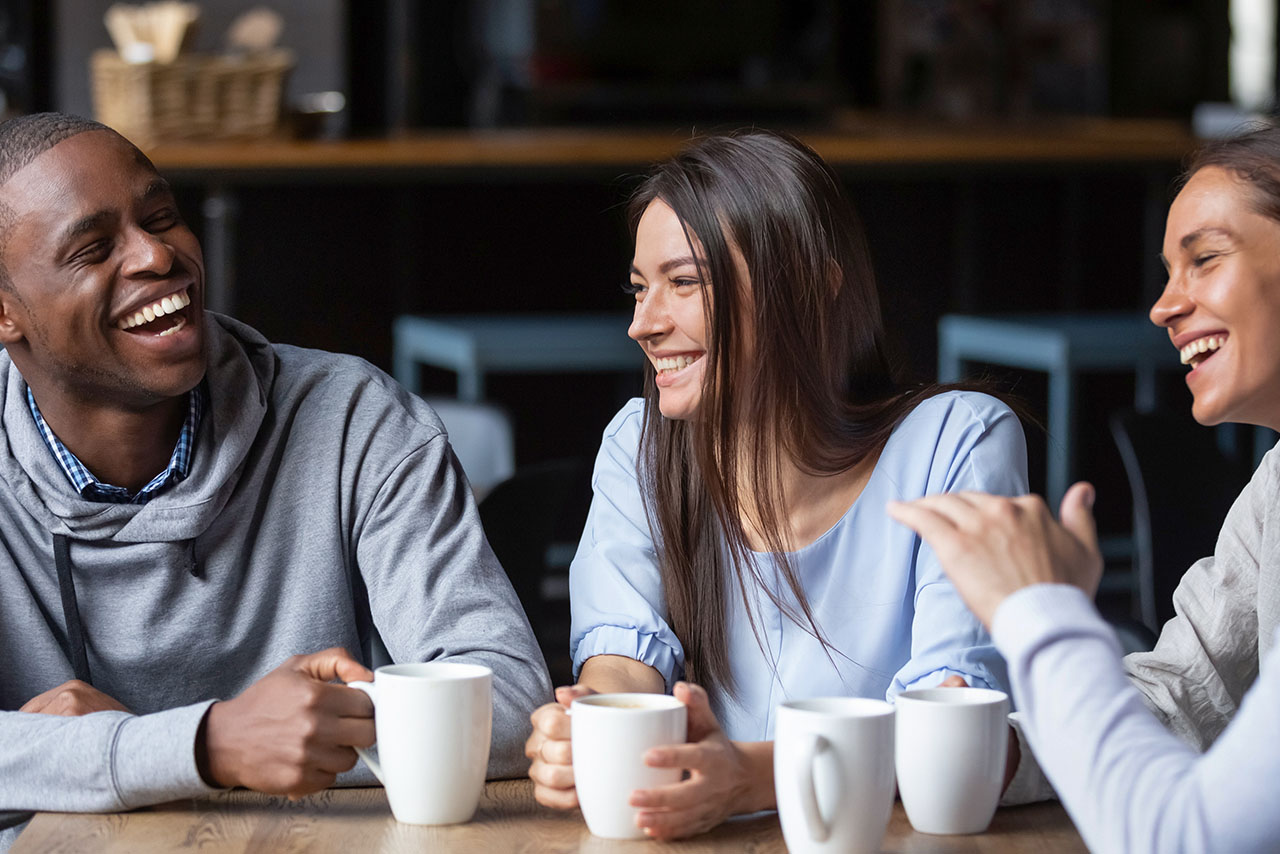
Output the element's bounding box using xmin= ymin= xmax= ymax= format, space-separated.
xmin=628 ymin=131 xmax=962 ymax=697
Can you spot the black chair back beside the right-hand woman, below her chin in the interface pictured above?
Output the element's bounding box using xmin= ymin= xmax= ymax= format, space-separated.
xmin=1111 ymin=410 xmax=1251 ymax=632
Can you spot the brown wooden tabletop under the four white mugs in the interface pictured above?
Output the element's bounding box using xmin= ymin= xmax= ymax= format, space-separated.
xmin=12 ymin=780 xmax=1085 ymax=854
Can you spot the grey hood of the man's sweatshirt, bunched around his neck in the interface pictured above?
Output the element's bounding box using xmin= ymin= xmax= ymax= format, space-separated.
xmin=0 ymin=311 xmax=278 ymax=543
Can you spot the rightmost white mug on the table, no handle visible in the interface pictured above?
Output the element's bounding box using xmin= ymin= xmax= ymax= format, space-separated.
xmin=893 ymin=688 xmax=1009 ymax=834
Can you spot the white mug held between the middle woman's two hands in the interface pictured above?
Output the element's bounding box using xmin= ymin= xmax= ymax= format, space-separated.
xmin=570 ymin=694 xmax=689 ymax=839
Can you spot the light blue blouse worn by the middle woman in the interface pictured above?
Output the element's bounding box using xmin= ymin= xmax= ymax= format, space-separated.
xmin=570 ymin=392 xmax=1027 ymax=741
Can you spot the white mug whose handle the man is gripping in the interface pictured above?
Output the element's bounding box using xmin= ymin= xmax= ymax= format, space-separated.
xmin=348 ymin=662 xmax=493 ymax=825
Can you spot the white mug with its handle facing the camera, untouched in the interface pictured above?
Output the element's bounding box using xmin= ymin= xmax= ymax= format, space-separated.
xmin=773 ymin=697 xmax=893 ymax=854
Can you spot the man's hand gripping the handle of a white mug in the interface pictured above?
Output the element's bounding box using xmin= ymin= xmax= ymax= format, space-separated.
xmin=196 ymin=649 xmax=375 ymax=796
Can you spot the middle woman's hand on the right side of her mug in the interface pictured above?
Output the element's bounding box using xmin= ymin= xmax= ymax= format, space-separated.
xmin=630 ymin=682 xmax=773 ymax=839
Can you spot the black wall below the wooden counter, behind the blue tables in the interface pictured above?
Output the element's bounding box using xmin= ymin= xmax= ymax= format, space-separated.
xmin=170 ymin=159 xmax=1172 ymax=512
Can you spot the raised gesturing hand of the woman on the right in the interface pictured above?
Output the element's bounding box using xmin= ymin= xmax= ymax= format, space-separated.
xmin=888 ymin=483 xmax=1102 ymax=629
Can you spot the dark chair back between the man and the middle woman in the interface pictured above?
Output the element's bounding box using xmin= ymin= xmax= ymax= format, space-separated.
xmin=480 ymin=458 xmax=591 ymax=685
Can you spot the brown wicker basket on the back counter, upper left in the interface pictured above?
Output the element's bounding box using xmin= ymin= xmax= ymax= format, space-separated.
xmin=91 ymin=50 xmax=293 ymax=147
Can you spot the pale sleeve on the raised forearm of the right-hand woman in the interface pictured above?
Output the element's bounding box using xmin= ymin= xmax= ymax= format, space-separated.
xmin=995 ymin=585 xmax=1280 ymax=854
